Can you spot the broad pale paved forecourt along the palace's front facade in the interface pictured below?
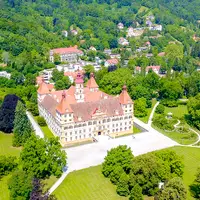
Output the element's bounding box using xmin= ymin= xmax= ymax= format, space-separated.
xmin=65 ymin=127 xmax=178 ymax=172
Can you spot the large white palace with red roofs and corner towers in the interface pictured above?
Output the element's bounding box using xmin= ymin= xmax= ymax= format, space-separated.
xmin=38 ymin=73 xmax=133 ymax=145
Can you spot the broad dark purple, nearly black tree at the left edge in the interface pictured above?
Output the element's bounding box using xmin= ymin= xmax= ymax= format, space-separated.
xmin=0 ymin=94 xmax=19 ymax=133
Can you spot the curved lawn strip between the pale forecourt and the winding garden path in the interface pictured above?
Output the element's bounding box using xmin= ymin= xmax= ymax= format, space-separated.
xmin=152 ymin=125 xmax=198 ymax=145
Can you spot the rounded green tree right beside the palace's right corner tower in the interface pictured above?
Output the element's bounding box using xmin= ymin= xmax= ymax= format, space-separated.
xmin=134 ymin=97 xmax=147 ymax=117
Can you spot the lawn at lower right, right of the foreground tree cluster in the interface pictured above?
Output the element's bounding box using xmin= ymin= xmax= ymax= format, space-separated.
xmin=170 ymin=147 xmax=200 ymax=200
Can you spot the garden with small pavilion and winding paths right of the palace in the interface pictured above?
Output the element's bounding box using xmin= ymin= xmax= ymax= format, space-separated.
xmin=152 ymin=104 xmax=198 ymax=145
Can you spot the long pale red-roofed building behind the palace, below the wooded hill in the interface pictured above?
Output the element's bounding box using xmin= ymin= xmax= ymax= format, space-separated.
xmin=49 ymin=46 xmax=83 ymax=63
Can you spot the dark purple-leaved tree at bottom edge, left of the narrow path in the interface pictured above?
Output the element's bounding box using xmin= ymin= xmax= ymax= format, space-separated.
xmin=30 ymin=178 xmax=56 ymax=200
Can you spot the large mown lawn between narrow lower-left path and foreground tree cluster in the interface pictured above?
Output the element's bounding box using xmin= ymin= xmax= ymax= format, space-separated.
xmin=55 ymin=166 xmax=128 ymax=200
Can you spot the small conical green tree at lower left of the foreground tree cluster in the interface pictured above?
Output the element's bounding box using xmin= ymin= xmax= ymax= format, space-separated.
xmin=116 ymin=172 xmax=129 ymax=197
